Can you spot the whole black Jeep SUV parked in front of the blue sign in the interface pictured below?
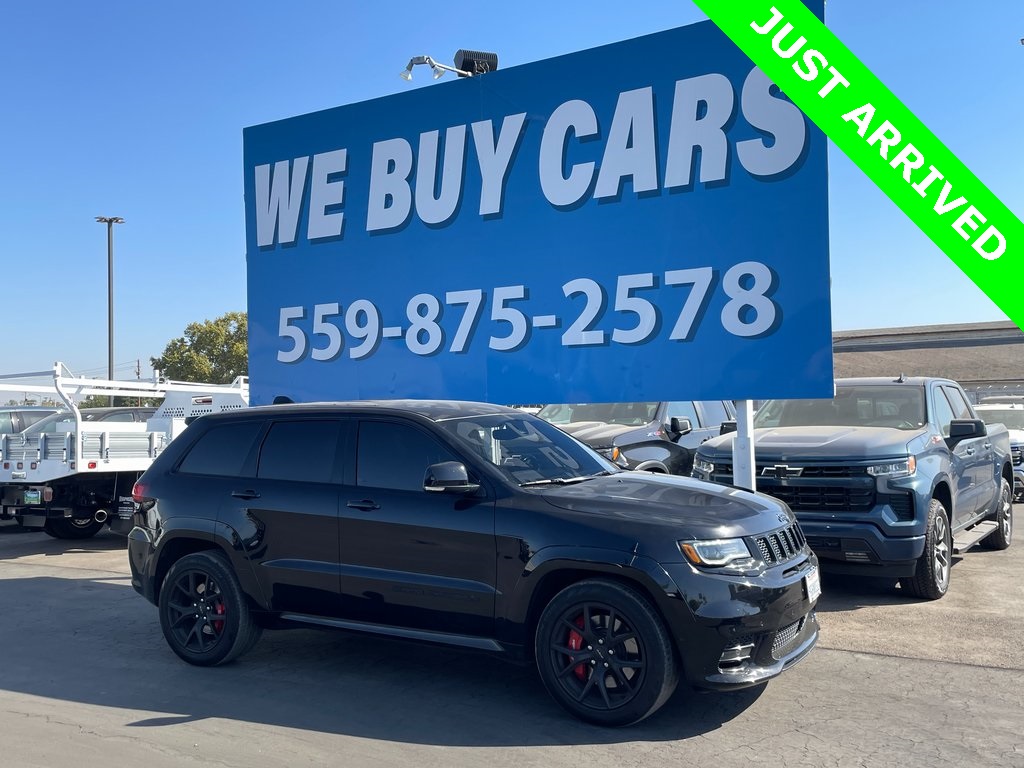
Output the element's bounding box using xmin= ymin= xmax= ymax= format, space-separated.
xmin=129 ymin=400 xmax=819 ymax=725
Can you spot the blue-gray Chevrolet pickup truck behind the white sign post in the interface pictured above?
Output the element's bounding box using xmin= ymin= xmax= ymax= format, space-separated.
xmin=693 ymin=376 xmax=1014 ymax=600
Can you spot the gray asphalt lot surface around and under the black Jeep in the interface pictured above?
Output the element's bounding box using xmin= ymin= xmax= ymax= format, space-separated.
xmin=0 ymin=512 xmax=1024 ymax=768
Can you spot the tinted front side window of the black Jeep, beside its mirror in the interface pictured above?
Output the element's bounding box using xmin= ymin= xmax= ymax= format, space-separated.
xmin=355 ymin=421 xmax=459 ymax=490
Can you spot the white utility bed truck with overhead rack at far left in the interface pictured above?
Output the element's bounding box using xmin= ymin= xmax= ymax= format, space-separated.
xmin=0 ymin=362 xmax=249 ymax=539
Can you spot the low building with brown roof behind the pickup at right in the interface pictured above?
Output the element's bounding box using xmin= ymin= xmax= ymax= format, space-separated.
xmin=833 ymin=321 xmax=1024 ymax=398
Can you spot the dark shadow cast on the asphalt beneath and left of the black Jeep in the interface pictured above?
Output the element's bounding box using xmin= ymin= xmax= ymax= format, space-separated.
xmin=0 ymin=577 xmax=764 ymax=746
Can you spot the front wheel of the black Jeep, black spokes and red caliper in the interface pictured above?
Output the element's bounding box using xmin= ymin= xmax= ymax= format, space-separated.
xmin=535 ymin=580 xmax=679 ymax=726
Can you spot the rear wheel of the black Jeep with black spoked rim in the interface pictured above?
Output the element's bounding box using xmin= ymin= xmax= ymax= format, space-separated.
xmin=159 ymin=552 xmax=261 ymax=667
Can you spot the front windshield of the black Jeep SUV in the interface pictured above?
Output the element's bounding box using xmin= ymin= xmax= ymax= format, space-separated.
xmin=437 ymin=414 xmax=617 ymax=485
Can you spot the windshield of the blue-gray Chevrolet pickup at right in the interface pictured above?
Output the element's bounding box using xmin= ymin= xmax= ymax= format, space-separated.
xmin=754 ymin=385 xmax=925 ymax=429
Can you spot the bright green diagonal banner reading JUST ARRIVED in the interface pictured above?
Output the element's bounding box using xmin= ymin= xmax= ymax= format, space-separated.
xmin=694 ymin=0 xmax=1024 ymax=328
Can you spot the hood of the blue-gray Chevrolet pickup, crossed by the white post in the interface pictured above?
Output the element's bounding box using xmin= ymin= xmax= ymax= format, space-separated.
xmin=700 ymin=427 xmax=926 ymax=461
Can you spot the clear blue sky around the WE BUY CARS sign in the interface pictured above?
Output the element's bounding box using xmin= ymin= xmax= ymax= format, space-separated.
xmin=0 ymin=0 xmax=1024 ymax=378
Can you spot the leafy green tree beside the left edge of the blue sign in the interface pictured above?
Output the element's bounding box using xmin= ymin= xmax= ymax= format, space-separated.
xmin=150 ymin=312 xmax=249 ymax=384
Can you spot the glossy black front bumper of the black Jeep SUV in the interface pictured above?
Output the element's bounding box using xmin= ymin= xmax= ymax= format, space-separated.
xmin=665 ymin=555 xmax=819 ymax=690
